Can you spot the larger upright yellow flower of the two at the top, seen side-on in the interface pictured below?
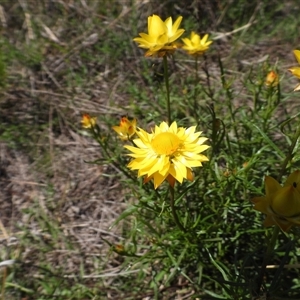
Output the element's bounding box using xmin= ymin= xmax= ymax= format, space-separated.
xmin=133 ymin=15 xmax=184 ymax=57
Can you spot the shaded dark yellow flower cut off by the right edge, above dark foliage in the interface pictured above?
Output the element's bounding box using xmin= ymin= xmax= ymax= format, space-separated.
xmin=252 ymin=171 xmax=300 ymax=231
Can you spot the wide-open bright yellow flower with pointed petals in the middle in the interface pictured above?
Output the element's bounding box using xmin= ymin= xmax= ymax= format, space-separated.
xmin=124 ymin=122 xmax=209 ymax=189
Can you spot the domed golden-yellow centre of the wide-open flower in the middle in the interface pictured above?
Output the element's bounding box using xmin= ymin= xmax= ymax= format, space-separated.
xmin=151 ymin=132 xmax=180 ymax=155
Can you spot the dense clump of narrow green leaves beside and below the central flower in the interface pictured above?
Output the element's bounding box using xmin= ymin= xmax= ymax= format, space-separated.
xmin=88 ymin=51 xmax=299 ymax=299
